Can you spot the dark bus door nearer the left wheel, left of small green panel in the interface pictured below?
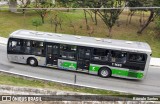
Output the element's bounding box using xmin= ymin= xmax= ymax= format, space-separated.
xmin=46 ymin=44 xmax=59 ymax=66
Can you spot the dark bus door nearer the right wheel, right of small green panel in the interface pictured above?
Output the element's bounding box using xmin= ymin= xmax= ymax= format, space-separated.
xmin=77 ymin=47 xmax=91 ymax=71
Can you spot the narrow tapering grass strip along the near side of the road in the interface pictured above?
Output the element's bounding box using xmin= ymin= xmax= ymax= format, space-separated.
xmin=0 ymin=73 xmax=126 ymax=95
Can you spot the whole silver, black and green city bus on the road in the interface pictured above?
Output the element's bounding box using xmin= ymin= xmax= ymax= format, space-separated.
xmin=7 ymin=30 xmax=151 ymax=79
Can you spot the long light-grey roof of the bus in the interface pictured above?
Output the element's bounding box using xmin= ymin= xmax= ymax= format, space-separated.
xmin=10 ymin=30 xmax=151 ymax=53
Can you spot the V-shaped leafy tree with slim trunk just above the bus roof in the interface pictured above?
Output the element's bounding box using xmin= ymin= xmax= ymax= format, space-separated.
xmin=91 ymin=0 xmax=125 ymax=37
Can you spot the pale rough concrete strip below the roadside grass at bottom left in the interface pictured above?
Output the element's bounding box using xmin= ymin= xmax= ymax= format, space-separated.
xmin=0 ymin=85 xmax=87 ymax=95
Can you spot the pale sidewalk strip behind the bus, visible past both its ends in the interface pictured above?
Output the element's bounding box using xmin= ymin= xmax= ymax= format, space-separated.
xmin=0 ymin=37 xmax=160 ymax=67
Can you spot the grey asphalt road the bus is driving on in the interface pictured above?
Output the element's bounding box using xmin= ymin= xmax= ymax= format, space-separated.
xmin=0 ymin=44 xmax=160 ymax=95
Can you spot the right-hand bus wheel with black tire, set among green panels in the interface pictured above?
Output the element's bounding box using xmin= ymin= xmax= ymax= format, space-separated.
xmin=98 ymin=67 xmax=112 ymax=78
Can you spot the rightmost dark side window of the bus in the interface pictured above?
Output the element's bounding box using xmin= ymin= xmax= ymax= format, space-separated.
xmin=129 ymin=53 xmax=146 ymax=62
